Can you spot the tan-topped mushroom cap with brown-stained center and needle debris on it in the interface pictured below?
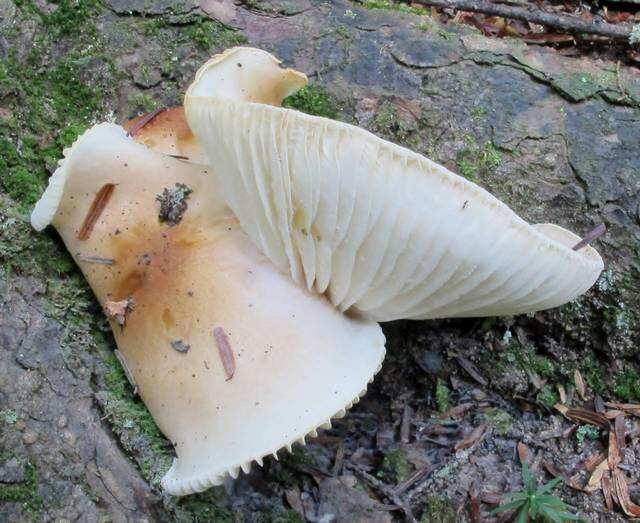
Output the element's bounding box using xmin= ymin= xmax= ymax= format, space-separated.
xmin=32 ymin=117 xmax=384 ymax=495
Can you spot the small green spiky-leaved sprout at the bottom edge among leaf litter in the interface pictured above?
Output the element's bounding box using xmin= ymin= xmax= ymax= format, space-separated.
xmin=490 ymin=463 xmax=582 ymax=523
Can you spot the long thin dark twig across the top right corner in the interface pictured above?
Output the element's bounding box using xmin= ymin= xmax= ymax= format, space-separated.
xmin=413 ymin=0 xmax=631 ymax=41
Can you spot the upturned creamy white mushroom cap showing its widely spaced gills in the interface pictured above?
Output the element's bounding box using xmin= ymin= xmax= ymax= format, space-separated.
xmin=185 ymin=47 xmax=603 ymax=321
